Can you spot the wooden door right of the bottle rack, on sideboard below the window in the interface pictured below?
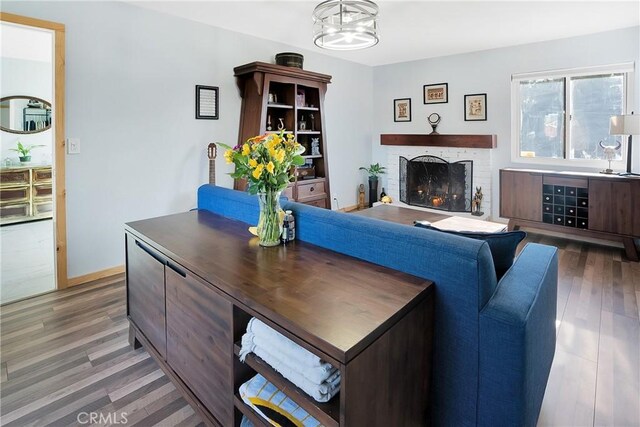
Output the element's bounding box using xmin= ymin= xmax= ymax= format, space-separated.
xmin=589 ymin=179 xmax=640 ymax=236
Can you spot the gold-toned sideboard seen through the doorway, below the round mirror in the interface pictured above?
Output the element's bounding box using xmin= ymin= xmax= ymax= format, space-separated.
xmin=0 ymin=165 xmax=53 ymax=225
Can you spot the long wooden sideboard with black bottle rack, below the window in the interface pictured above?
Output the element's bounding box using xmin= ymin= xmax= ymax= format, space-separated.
xmin=500 ymin=169 xmax=640 ymax=261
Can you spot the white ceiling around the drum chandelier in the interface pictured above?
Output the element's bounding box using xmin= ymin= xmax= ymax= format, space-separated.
xmin=128 ymin=0 xmax=640 ymax=66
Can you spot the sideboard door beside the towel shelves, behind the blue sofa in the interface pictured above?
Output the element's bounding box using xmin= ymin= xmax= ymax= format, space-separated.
xmin=166 ymin=268 xmax=233 ymax=426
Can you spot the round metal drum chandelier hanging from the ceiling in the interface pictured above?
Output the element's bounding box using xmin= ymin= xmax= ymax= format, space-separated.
xmin=313 ymin=0 xmax=378 ymax=50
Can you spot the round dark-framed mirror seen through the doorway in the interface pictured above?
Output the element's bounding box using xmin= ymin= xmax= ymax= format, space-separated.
xmin=0 ymin=95 xmax=51 ymax=133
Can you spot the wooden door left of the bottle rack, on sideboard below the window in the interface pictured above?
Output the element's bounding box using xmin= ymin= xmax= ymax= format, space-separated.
xmin=500 ymin=170 xmax=542 ymax=221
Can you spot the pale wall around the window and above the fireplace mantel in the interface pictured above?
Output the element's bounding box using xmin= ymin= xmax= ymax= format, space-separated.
xmin=372 ymin=27 xmax=640 ymax=218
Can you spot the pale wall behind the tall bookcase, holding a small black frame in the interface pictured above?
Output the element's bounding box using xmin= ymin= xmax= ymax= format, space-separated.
xmin=2 ymin=1 xmax=373 ymax=277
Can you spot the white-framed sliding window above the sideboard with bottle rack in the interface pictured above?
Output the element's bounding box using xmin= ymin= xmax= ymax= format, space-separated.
xmin=512 ymin=64 xmax=633 ymax=166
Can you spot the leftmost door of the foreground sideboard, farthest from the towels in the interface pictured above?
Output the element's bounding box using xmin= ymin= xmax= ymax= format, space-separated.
xmin=127 ymin=234 xmax=167 ymax=358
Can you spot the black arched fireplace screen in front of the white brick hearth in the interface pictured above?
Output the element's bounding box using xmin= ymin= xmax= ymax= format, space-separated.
xmin=400 ymin=156 xmax=473 ymax=212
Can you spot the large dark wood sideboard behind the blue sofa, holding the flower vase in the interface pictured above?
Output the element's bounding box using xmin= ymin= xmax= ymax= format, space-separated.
xmin=125 ymin=211 xmax=433 ymax=427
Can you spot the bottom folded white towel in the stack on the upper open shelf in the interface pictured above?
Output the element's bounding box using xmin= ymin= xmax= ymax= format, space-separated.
xmin=245 ymin=334 xmax=341 ymax=402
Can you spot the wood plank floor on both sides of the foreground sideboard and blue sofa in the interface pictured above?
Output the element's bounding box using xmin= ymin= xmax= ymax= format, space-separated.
xmin=0 ymin=232 xmax=640 ymax=426
